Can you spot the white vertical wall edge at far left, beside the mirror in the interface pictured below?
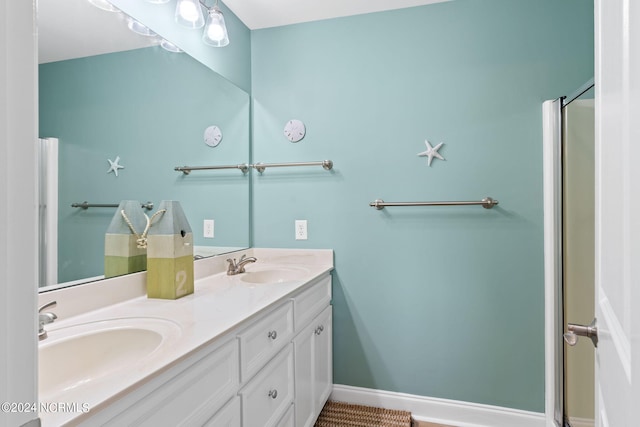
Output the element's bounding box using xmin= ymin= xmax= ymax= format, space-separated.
xmin=0 ymin=1 xmax=37 ymax=427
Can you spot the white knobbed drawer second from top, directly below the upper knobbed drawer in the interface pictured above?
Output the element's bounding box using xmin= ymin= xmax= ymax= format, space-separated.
xmin=240 ymin=344 xmax=293 ymax=427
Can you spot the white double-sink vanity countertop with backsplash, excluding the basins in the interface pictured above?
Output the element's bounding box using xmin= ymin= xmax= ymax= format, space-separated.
xmin=39 ymin=248 xmax=333 ymax=426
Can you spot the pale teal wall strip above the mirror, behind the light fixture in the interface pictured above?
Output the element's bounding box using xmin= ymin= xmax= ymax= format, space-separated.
xmin=110 ymin=0 xmax=251 ymax=92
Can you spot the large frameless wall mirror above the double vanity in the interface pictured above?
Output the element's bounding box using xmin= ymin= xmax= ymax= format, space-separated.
xmin=38 ymin=0 xmax=250 ymax=290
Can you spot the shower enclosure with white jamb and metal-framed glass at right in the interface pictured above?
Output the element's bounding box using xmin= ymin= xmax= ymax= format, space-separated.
xmin=543 ymin=81 xmax=595 ymax=427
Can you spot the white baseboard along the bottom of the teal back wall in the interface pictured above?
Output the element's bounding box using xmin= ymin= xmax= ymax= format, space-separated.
xmin=331 ymin=384 xmax=546 ymax=427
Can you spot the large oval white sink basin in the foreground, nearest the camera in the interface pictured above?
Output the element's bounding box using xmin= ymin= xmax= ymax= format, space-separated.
xmin=38 ymin=317 xmax=180 ymax=401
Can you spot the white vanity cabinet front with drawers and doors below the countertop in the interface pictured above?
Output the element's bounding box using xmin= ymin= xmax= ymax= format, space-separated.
xmin=69 ymin=274 xmax=332 ymax=427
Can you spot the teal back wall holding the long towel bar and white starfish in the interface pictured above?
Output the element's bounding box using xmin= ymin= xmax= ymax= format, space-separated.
xmin=251 ymin=0 xmax=593 ymax=412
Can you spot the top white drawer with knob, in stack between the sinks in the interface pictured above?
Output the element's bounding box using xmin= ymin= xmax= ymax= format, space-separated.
xmin=238 ymin=302 xmax=293 ymax=382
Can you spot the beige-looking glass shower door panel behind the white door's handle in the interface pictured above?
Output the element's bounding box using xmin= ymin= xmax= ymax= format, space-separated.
xmin=562 ymin=88 xmax=595 ymax=427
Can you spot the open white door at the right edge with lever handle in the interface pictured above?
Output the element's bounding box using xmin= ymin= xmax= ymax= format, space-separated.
xmin=595 ymin=0 xmax=640 ymax=427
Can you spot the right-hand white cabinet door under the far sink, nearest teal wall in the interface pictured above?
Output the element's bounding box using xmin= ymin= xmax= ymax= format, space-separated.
xmin=313 ymin=306 xmax=333 ymax=414
